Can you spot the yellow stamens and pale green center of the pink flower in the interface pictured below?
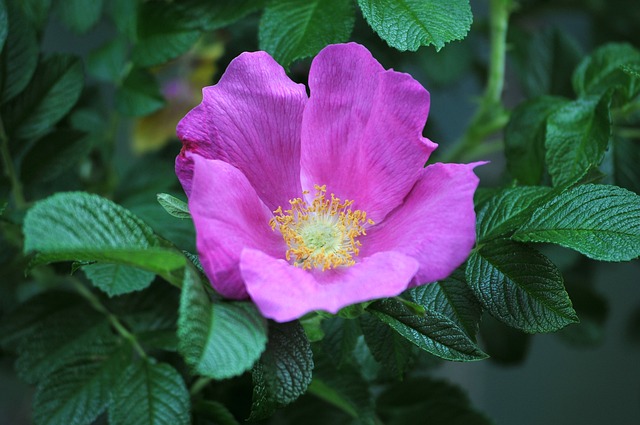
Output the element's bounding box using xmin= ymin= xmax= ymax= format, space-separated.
xmin=269 ymin=185 xmax=374 ymax=271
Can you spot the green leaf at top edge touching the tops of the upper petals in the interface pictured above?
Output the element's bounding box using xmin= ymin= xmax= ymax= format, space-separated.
xmin=258 ymin=0 xmax=355 ymax=66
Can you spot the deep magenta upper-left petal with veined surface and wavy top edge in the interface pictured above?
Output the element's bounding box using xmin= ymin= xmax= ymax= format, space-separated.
xmin=176 ymin=52 xmax=307 ymax=210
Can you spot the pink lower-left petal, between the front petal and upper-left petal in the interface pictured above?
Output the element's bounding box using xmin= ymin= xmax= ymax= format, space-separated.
xmin=189 ymin=155 xmax=286 ymax=299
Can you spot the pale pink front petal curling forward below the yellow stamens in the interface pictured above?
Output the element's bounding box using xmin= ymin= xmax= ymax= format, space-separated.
xmin=240 ymin=249 xmax=418 ymax=322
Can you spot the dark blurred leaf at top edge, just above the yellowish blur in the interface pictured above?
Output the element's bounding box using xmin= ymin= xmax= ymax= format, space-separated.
xmin=131 ymin=2 xmax=200 ymax=67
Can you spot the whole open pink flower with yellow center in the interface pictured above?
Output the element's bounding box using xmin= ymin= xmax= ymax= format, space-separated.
xmin=176 ymin=43 xmax=478 ymax=322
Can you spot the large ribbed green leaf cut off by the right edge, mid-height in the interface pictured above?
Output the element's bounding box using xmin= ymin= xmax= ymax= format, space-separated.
xmin=513 ymin=184 xmax=640 ymax=261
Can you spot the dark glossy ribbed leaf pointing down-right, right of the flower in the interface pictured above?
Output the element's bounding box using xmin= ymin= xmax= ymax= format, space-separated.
xmin=467 ymin=240 xmax=578 ymax=333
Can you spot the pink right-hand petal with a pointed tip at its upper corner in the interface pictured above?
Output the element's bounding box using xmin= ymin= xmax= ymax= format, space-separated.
xmin=360 ymin=163 xmax=482 ymax=285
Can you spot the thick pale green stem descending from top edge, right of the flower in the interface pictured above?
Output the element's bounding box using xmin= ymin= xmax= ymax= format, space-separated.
xmin=443 ymin=0 xmax=513 ymax=162
